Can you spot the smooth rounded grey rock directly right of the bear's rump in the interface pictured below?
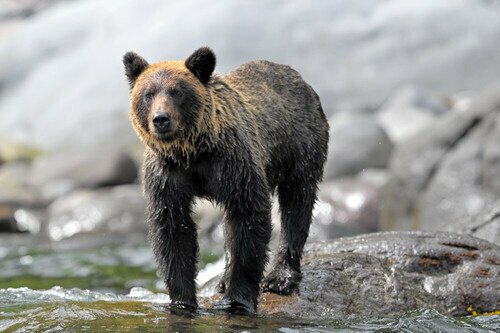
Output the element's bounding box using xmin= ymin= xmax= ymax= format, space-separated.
xmin=324 ymin=114 xmax=392 ymax=180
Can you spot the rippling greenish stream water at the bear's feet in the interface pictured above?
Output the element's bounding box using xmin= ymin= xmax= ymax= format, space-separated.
xmin=0 ymin=240 xmax=500 ymax=332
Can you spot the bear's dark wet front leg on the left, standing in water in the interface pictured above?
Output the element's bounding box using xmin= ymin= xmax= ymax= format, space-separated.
xmin=144 ymin=164 xmax=198 ymax=308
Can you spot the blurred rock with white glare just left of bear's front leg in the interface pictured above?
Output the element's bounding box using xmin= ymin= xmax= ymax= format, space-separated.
xmin=45 ymin=185 xmax=146 ymax=245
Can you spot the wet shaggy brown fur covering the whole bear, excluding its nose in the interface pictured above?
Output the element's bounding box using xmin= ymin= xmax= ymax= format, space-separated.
xmin=123 ymin=48 xmax=328 ymax=311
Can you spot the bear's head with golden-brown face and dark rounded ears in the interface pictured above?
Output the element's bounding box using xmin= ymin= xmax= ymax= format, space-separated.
xmin=123 ymin=47 xmax=215 ymax=151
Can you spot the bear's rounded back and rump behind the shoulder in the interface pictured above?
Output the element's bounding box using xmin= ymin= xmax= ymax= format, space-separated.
xmin=222 ymin=60 xmax=328 ymax=188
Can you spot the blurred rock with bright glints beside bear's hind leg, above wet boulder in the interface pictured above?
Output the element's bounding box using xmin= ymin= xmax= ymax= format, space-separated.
xmin=310 ymin=178 xmax=381 ymax=240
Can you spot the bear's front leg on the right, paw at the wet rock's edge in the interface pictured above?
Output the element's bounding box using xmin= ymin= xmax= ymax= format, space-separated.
xmin=214 ymin=167 xmax=271 ymax=312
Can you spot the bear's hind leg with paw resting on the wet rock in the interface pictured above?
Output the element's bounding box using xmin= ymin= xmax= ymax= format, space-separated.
xmin=262 ymin=173 xmax=317 ymax=295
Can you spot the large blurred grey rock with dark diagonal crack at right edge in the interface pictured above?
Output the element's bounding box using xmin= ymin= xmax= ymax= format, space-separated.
xmin=383 ymin=85 xmax=500 ymax=231
